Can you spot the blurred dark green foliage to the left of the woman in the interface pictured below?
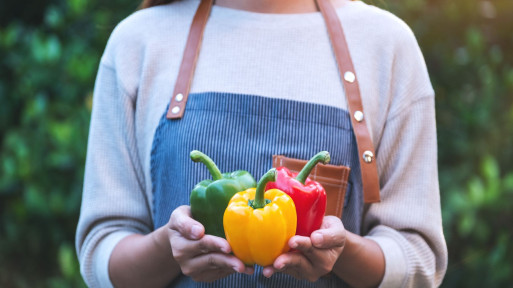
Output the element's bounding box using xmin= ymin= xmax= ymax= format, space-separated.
xmin=0 ymin=0 xmax=139 ymax=287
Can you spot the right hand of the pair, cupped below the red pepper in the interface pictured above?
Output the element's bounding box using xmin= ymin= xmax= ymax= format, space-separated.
xmin=263 ymin=216 xmax=346 ymax=282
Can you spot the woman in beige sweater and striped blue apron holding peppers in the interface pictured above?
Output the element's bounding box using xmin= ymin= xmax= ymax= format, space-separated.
xmin=77 ymin=0 xmax=447 ymax=287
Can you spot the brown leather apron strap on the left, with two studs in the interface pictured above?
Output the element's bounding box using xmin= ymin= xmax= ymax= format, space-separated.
xmin=166 ymin=0 xmax=214 ymax=119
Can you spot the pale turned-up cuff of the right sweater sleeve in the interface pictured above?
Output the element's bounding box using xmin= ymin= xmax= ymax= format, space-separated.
xmin=365 ymin=226 xmax=408 ymax=288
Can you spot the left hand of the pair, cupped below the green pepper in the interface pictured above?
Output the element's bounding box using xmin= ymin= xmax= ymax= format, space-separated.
xmin=168 ymin=206 xmax=253 ymax=282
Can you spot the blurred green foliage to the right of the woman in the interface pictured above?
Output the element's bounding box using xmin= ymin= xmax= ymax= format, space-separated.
xmin=376 ymin=0 xmax=513 ymax=287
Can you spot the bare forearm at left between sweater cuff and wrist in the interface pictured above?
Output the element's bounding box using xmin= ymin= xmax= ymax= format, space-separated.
xmin=109 ymin=226 xmax=180 ymax=287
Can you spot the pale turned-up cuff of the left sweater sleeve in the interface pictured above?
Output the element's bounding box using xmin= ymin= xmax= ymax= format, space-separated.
xmin=92 ymin=231 xmax=133 ymax=288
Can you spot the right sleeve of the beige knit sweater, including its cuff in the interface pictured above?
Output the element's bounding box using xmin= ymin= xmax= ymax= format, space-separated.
xmin=363 ymin=22 xmax=447 ymax=287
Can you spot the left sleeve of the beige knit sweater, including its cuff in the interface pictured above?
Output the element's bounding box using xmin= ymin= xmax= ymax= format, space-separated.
xmin=76 ymin=62 xmax=152 ymax=287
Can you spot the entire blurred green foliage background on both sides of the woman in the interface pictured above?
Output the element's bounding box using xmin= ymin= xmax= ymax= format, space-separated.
xmin=0 ymin=0 xmax=513 ymax=287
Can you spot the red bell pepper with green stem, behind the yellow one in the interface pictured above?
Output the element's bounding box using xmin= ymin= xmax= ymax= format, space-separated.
xmin=266 ymin=151 xmax=330 ymax=237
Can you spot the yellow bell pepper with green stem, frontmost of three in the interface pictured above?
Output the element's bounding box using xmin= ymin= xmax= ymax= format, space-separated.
xmin=224 ymin=168 xmax=297 ymax=266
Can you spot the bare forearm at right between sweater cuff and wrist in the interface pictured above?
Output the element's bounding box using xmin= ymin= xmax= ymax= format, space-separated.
xmin=333 ymin=231 xmax=385 ymax=287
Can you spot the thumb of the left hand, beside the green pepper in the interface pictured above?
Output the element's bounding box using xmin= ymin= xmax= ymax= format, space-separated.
xmin=169 ymin=205 xmax=205 ymax=240
